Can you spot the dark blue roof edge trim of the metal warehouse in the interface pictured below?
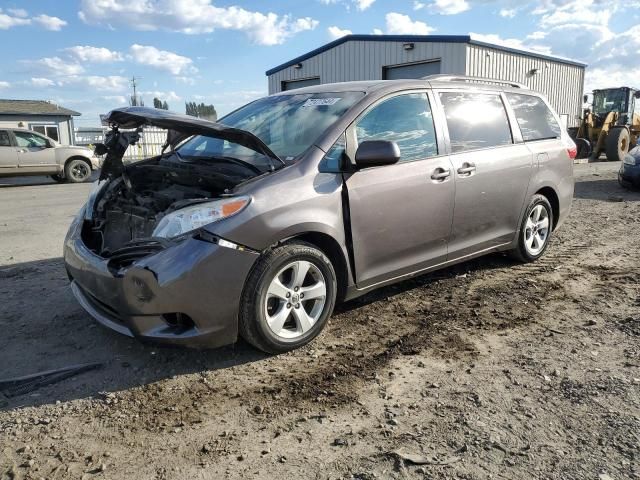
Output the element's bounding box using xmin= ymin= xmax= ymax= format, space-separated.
xmin=266 ymin=34 xmax=587 ymax=76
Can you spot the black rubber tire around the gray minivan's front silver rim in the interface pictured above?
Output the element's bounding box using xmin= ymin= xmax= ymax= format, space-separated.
xmin=238 ymin=241 xmax=337 ymax=353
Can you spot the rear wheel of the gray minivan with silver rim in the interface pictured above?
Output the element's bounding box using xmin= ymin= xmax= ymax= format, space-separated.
xmin=510 ymin=195 xmax=553 ymax=263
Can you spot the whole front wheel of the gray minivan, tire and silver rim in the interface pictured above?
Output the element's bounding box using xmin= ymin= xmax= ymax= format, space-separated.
xmin=238 ymin=242 xmax=337 ymax=353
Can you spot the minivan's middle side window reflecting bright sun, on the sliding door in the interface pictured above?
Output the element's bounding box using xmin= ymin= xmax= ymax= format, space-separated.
xmin=440 ymin=92 xmax=513 ymax=153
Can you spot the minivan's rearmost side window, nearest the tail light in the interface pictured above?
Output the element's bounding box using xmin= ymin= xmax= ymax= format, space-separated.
xmin=507 ymin=93 xmax=561 ymax=142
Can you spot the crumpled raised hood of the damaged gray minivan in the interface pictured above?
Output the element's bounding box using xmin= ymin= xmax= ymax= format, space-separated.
xmin=103 ymin=107 xmax=282 ymax=163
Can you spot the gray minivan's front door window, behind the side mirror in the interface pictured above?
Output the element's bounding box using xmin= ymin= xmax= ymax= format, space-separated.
xmin=356 ymin=93 xmax=438 ymax=162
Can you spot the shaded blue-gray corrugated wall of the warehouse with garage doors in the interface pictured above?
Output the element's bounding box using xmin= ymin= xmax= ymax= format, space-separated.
xmin=269 ymin=41 xmax=466 ymax=93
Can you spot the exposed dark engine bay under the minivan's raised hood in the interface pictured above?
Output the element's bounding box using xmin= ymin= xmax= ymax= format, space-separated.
xmin=83 ymin=153 xmax=255 ymax=257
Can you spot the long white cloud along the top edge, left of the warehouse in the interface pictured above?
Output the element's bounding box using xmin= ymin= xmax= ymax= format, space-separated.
xmin=78 ymin=0 xmax=318 ymax=45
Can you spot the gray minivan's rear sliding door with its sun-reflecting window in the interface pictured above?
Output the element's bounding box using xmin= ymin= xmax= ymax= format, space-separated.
xmin=438 ymin=90 xmax=533 ymax=260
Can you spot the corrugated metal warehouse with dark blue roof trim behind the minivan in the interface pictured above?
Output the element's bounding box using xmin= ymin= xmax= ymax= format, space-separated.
xmin=267 ymin=35 xmax=586 ymax=126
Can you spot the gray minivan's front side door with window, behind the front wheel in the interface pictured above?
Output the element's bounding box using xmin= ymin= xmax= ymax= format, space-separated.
xmin=345 ymin=92 xmax=454 ymax=288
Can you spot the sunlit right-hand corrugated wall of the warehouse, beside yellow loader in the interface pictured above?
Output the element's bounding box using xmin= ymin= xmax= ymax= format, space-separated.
xmin=466 ymin=45 xmax=584 ymax=127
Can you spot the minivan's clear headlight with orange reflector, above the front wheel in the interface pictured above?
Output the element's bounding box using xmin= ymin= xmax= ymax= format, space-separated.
xmin=153 ymin=196 xmax=251 ymax=238
